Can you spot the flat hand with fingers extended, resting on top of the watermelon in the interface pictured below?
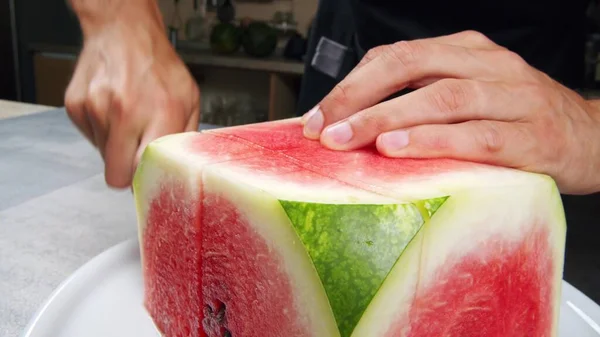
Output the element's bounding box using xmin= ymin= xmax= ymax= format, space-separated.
xmin=302 ymin=32 xmax=600 ymax=194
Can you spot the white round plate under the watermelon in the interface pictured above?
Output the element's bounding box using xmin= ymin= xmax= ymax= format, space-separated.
xmin=23 ymin=240 xmax=600 ymax=337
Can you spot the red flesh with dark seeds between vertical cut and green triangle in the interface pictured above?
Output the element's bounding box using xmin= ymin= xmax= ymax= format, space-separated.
xmin=198 ymin=193 xmax=309 ymax=336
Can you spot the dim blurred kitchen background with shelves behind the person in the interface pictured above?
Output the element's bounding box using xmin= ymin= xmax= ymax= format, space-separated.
xmin=0 ymin=0 xmax=600 ymax=125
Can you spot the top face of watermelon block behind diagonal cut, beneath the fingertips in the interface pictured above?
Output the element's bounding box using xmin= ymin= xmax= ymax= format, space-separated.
xmin=209 ymin=119 xmax=529 ymax=199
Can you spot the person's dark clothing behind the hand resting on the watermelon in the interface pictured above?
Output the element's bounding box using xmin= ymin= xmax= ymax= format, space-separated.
xmin=298 ymin=0 xmax=591 ymax=114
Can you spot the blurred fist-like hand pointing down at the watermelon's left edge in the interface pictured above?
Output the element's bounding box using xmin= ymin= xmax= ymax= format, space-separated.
xmin=65 ymin=7 xmax=199 ymax=188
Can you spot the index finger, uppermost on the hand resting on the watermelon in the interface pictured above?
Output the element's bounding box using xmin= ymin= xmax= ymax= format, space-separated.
xmin=304 ymin=42 xmax=506 ymax=139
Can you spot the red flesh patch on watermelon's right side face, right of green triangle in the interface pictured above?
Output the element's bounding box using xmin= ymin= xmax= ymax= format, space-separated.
xmin=398 ymin=223 xmax=554 ymax=337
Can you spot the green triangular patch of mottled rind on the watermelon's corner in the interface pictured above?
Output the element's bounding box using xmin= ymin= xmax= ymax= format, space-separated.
xmin=279 ymin=197 xmax=447 ymax=337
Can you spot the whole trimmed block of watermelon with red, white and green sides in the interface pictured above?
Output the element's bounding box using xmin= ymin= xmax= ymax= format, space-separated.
xmin=134 ymin=119 xmax=566 ymax=337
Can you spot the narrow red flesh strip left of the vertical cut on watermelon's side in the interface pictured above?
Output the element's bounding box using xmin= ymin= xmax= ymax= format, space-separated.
xmin=142 ymin=179 xmax=202 ymax=336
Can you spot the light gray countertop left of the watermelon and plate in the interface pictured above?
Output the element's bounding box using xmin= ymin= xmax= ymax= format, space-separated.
xmin=0 ymin=109 xmax=214 ymax=337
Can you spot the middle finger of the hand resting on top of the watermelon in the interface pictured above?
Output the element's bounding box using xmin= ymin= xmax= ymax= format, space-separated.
xmin=321 ymin=79 xmax=521 ymax=150
